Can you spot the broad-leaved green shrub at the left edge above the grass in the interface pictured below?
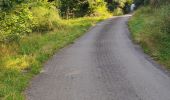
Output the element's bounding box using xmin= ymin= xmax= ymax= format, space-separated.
xmin=0 ymin=5 xmax=33 ymax=43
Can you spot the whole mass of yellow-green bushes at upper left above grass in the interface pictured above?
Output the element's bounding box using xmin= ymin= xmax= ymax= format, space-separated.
xmin=0 ymin=1 xmax=60 ymax=43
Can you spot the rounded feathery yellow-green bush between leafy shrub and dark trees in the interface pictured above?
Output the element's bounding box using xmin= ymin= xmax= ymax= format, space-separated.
xmin=31 ymin=2 xmax=60 ymax=32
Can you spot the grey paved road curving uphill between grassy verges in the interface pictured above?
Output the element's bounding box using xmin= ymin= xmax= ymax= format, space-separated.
xmin=26 ymin=15 xmax=170 ymax=100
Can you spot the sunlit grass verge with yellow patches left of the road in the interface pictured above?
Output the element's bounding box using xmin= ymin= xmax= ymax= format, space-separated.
xmin=0 ymin=17 xmax=105 ymax=100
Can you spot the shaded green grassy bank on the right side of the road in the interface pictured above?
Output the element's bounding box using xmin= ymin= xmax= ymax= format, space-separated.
xmin=129 ymin=4 xmax=170 ymax=70
